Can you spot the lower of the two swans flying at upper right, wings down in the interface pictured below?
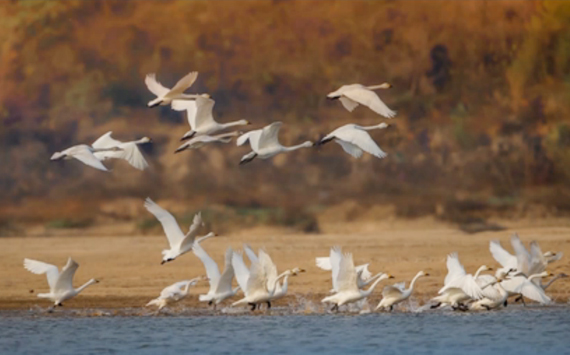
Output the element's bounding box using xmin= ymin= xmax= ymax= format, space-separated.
xmin=315 ymin=122 xmax=388 ymax=158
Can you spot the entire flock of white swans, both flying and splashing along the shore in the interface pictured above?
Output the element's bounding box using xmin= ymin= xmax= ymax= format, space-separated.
xmin=24 ymin=72 xmax=566 ymax=311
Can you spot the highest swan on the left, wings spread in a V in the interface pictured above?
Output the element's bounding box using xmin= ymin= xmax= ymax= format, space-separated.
xmin=144 ymin=71 xmax=202 ymax=107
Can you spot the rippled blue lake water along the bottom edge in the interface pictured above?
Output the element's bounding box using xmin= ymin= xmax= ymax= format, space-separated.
xmin=0 ymin=307 xmax=570 ymax=355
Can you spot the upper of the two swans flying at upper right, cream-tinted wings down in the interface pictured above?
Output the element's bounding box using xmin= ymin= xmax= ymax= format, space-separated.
xmin=327 ymin=83 xmax=396 ymax=118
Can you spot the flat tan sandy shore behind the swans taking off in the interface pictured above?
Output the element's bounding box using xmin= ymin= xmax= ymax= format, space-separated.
xmin=0 ymin=219 xmax=570 ymax=310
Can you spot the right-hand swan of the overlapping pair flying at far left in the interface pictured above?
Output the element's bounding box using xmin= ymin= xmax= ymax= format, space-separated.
xmin=91 ymin=131 xmax=152 ymax=170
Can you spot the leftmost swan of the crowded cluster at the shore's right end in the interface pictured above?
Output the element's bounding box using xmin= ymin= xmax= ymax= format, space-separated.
xmin=432 ymin=253 xmax=495 ymax=309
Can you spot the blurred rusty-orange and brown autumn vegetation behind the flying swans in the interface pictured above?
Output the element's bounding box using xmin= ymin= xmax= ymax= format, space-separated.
xmin=0 ymin=1 xmax=570 ymax=234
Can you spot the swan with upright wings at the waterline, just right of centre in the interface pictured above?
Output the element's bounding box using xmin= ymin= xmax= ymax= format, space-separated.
xmin=321 ymin=253 xmax=394 ymax=311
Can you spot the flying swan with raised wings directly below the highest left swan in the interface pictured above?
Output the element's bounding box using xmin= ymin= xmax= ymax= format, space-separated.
xmin=176 ymin=95 xmax=251 ymax=141
